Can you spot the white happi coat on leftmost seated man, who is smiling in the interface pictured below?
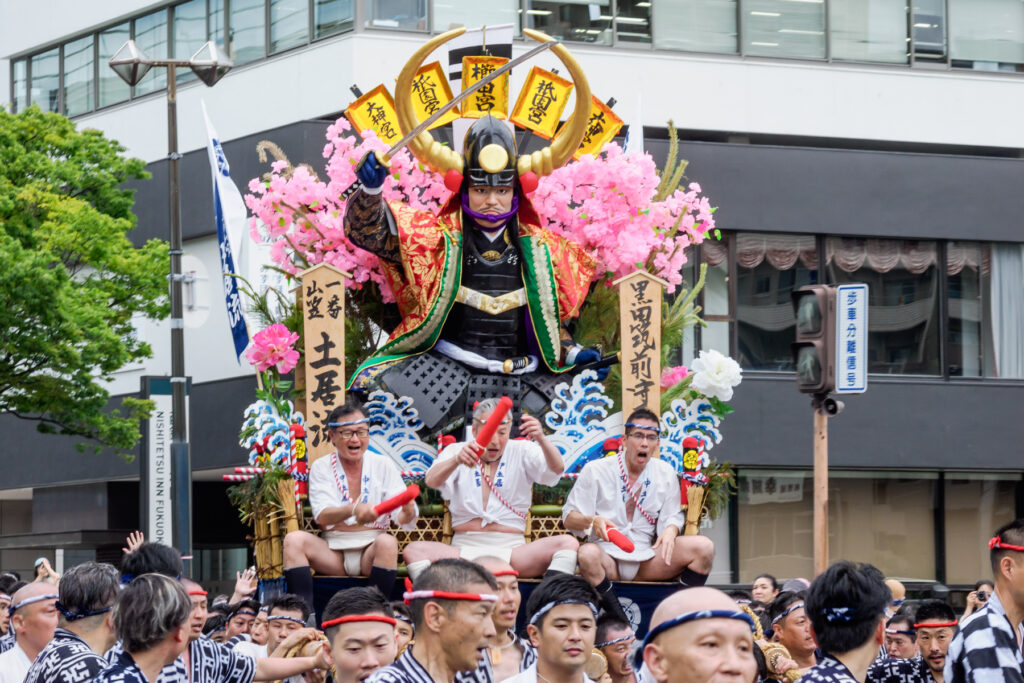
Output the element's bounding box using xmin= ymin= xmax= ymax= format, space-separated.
xmin=309 ymin=451 xmax=420 ymax=548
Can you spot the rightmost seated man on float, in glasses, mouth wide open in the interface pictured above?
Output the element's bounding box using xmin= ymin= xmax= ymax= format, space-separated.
xmin=562 ymin=409 xmax=715 ymax=608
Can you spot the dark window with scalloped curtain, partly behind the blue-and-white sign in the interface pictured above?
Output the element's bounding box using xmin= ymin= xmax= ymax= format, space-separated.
xmin=826 ymin=238 xmax=941 ymax=375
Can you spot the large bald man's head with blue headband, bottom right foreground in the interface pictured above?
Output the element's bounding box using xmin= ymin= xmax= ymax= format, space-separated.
xmin=643 ymin=587 xmax=757 ymax=683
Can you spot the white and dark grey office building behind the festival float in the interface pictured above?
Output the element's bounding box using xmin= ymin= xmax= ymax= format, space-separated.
xmin=0 ymin=0 xmax=1024 ymax=586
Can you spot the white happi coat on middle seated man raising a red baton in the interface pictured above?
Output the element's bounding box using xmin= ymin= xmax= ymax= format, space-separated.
xmin=436 ymin=439 xmax=561 ymax=530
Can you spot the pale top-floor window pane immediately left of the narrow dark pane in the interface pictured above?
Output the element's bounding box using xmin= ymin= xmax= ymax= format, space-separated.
xmin=828 ymin=0 xmax=909 ymax=63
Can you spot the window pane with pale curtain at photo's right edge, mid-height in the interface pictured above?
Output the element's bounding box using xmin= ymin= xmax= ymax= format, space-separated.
xmin=982 ymin=243 xmax=1024 ymax=379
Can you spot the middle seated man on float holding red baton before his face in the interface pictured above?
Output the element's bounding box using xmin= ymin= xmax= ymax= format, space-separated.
xmin=404 ymin=398 xmax=581 ymax=582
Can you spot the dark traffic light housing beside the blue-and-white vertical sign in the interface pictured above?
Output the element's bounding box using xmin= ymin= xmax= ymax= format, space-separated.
xmin=793 ymin=285 xmax=836 ymax=394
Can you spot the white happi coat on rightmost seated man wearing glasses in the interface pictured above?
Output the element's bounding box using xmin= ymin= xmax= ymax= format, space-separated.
xmin=562 ymin=454 xmax=686 ymax=562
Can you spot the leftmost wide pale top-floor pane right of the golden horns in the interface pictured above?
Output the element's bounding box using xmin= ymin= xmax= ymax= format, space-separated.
xmin=654 ymin=0 xmax=739 ymax=54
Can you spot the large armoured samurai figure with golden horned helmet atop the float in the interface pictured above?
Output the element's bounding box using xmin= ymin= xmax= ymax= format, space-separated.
xmin=344 ymin=32 xmax=607 ymax=434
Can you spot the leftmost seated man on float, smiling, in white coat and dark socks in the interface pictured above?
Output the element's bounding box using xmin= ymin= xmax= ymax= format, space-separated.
xmin=284 ymin=399 xmax=420 ymax=607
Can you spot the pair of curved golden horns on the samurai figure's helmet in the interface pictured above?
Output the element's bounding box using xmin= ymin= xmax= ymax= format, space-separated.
xmin=394 ymin=28 xmax=591 ymax=177
